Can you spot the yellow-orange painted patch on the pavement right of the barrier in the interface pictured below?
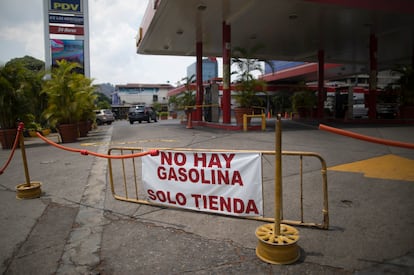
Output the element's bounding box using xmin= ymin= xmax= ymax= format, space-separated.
xmin=328 ymin=154 xmax=414 ymax=181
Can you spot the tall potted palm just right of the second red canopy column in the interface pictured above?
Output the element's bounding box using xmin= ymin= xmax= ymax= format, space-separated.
xmin=232 ymin=45 xmax=273 ymax=125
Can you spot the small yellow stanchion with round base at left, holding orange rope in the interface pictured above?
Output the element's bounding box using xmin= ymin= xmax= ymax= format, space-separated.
xmin=16 ymin=122 xmax=42 ymax=199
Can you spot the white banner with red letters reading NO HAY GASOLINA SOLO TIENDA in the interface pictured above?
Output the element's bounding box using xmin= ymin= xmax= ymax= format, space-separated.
xmin=142 ymin=151 xmax=263 ymax=216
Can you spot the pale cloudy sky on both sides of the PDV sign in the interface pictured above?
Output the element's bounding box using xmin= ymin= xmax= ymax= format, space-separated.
xmin=0 ymin=0 xmax=201 ymax=85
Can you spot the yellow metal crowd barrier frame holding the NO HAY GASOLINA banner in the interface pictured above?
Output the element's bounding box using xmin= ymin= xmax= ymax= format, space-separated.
xmin=108 ymin=147 xmax=329 ymax=229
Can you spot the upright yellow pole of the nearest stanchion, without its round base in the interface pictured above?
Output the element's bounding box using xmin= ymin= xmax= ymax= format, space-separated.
xmin=274 ymin=115 xmax=282 ymax=236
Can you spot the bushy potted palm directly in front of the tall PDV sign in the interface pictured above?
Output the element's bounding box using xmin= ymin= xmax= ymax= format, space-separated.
xmin=42 ymin=60 xmax=91 ymax=143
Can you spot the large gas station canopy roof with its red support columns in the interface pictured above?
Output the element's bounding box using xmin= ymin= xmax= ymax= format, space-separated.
xmin=137 ymin=0 xmax=414 ymax=124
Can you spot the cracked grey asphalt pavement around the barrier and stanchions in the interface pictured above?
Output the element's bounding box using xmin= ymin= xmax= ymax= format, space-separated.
xmin=0 ymin=120 xmax=414 ymax=274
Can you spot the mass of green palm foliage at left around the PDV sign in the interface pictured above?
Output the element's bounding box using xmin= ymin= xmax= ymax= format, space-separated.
xmin=0 ymin=56 xmax=110 ymax=130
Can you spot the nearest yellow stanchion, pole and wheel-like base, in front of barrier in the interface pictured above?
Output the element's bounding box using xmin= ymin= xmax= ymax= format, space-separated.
xmin=256 ymin=115 xmax=300 ymax=264
